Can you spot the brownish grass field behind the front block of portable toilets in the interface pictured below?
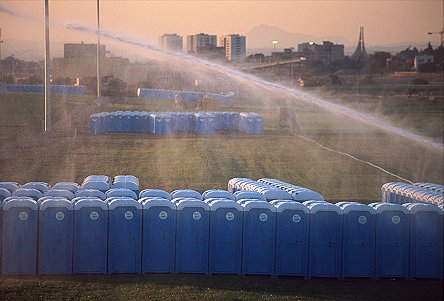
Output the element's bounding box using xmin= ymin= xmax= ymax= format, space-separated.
xmin=0 ymin=93 xmax=443 ymax=202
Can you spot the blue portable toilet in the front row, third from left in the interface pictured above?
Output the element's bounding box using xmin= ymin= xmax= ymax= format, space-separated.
xmin=73 ymin=198 xmax=108 ymax=274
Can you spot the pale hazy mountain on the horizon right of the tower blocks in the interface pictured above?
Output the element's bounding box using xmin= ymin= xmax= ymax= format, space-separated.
xmin=245 ymin=24 xmax=351 ymax=51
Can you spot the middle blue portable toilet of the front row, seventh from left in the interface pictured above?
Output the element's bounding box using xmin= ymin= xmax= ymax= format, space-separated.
xmin=209 ymin=200 xmax=243 ymax=275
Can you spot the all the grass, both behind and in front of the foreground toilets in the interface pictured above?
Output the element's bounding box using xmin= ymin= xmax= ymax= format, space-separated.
xmin=0 ymin=92 xmax=443 ymax=300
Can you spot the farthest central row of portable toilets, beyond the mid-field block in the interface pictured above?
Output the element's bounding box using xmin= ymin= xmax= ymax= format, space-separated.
xmin=137 ymin=88 xmax=235 ymax=104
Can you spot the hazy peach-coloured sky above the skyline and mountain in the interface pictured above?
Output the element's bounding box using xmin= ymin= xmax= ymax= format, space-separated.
xmin=0 ymin=0 xmax=443 ymax=45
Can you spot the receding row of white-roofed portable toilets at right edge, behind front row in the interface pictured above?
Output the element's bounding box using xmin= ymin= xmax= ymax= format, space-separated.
xmin=381 ymin=182 xmax=444 ymax=207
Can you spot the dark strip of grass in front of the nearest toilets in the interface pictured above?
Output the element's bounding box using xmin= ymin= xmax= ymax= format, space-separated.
xmin=0 ymin=275 xmax=442 ymax=301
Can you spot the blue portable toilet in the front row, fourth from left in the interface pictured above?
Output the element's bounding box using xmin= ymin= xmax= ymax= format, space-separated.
xmin=108 ymin=198 xmax=142 ymax=274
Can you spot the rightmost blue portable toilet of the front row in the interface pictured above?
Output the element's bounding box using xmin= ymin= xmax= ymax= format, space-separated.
xmin=405 ymin=204 xmax=443 ymax=279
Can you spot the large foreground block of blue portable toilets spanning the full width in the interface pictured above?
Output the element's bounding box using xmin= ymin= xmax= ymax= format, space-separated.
xmin=0 ymin=175 xmax=443 ymax=279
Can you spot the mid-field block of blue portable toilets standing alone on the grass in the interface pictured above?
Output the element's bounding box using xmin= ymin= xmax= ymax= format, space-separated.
xmin=90 ymin=111 xmax=264 ymax=135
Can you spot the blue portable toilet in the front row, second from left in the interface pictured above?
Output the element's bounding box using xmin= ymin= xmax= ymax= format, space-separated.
xmin=38 ymin=199 xmax=73 ymax=275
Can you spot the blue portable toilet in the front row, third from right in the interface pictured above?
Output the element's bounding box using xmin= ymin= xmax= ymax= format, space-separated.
xmin=336 ymin=202 xmax=376 ymax=278
